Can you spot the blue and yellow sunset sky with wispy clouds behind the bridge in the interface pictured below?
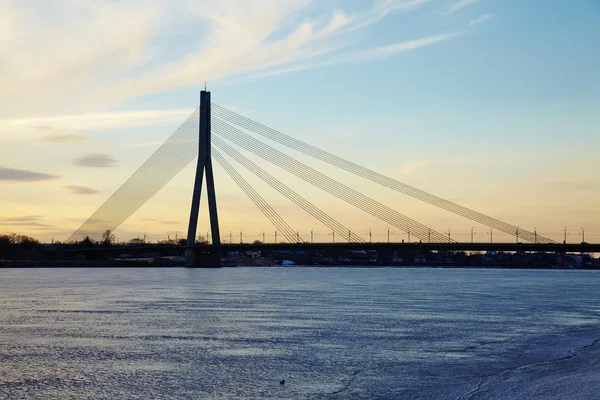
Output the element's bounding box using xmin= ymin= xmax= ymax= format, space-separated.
xmin=0 ymin=0 xmax=600 ymax=242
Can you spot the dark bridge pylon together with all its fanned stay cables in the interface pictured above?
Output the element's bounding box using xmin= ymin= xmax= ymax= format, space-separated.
xmin=69 ymin=91 xmax=592 ymax=264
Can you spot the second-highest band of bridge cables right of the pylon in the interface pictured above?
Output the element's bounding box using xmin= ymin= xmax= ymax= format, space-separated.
xmin=212 ymin=118 xmax=452 ymax=242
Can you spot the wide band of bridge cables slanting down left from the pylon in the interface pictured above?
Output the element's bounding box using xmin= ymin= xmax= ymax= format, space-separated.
xmin=68 ymin=109 xmax=199 ymax=241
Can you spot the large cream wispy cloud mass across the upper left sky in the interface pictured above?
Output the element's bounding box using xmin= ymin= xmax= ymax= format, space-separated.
xmin=0 ymin=0 xmax=454 ymax=118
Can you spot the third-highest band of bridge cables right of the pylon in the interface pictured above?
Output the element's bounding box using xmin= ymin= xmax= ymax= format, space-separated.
xmin=212 ymin=137 xmax=364 ymax=243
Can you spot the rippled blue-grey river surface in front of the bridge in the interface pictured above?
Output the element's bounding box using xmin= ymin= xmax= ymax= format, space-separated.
xmin=0 ymin=267 xmax=600 ymax=399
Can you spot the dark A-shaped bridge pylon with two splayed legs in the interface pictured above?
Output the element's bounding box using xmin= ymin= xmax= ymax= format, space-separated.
xmin=186 ymin=90 xmax=221 ymax=265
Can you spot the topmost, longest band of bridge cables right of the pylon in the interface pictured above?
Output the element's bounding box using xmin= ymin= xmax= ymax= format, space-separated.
xmin=212 ymin=103 xmax=556 ymax=243
